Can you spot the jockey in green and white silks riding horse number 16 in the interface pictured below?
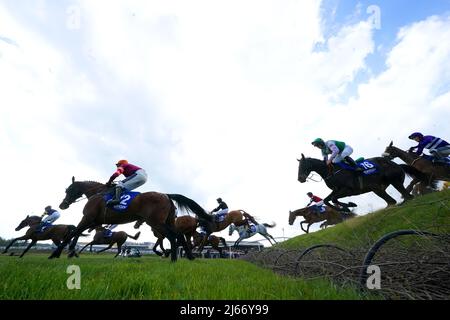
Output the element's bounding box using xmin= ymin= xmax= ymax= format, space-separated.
xmin=311 ymin=138 xmax=362 ymax=171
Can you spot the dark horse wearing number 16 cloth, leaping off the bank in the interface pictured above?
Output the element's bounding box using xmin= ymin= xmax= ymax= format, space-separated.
xmin=297 ymin=154 xmax=413 ymax=212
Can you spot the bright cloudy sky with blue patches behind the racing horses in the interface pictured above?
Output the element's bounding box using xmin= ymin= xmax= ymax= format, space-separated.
xmin=0 ymin=0 xmax=450 ymax=245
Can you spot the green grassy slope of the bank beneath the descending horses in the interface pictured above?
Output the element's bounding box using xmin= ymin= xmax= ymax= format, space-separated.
xmin=276 ymin=190 xmax=450 ymax=249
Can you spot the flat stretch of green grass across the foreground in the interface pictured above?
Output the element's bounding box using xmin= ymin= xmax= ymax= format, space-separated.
xmin=0 ymin=253 xmax=364 ymax=300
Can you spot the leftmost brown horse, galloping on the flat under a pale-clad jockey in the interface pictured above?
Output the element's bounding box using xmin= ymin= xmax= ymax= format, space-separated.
xmin=2 ymin=215 xmax=86 ymax=258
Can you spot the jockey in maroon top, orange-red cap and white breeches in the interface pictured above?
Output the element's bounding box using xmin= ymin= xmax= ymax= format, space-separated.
xmin=106 ymin=160 xmax=147 ymax=206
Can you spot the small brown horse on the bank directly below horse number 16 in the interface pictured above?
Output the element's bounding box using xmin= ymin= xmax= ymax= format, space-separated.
xmin=289 ymin=206 xmax=356 ymax=233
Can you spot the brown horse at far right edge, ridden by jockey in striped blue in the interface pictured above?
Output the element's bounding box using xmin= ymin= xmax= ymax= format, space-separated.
xmin=382 ymin=141 xmax=450 ymax=192
